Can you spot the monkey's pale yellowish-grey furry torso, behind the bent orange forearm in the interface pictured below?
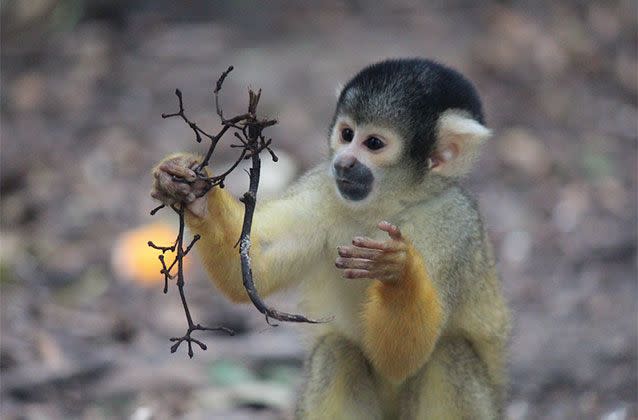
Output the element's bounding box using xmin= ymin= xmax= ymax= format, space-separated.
xmin=292 ymin=167 xmax=509 ymax=398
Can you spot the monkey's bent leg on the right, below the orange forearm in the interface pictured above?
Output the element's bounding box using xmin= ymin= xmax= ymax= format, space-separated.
xmin=399 ymin=337 xmax=502 ymax=420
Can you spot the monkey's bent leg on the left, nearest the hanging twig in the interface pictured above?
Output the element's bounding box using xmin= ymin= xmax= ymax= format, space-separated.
xmin=296 ymin=333 xmax=381 ymax=420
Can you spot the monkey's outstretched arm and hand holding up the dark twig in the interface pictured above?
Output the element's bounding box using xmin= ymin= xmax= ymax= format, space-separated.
xmin=152 ymin=154 xmax=323 ymax=302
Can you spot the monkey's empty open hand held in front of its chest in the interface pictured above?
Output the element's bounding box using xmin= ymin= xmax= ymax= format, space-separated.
xmin=335 ymin=222 xmax=408 ymax=283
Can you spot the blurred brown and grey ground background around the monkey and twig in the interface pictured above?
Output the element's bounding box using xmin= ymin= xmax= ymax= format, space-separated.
xmin=0 ymin=0 xmax=638 ymax=420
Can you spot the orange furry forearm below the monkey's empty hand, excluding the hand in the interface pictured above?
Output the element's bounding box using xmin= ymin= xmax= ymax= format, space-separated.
xmin=363 ymin=244 xmax=443 ymax=382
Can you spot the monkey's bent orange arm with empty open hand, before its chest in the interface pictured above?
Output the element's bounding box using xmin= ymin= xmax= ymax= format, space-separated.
xmin=336 ymin=222 xmax=447 ymax=382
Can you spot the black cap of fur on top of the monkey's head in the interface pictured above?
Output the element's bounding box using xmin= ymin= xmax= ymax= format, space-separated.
xmin=333 ymin=58 xmax=484 ymax=167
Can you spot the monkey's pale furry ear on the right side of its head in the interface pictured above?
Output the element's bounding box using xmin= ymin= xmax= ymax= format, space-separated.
xmin=428 ymin=112 xmax=492 ymax=177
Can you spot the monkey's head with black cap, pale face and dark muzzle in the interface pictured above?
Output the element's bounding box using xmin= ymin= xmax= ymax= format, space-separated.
xmin=330 ymin=59 xmax=490 ymax=202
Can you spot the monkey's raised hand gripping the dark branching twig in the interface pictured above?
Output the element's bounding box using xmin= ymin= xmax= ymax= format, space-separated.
xmin=151 ymin=153 xmax=210 ymax=218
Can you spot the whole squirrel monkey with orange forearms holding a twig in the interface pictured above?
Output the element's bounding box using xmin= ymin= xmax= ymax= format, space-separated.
xmin=152 ymin=59 xmax=509 ymax=420
